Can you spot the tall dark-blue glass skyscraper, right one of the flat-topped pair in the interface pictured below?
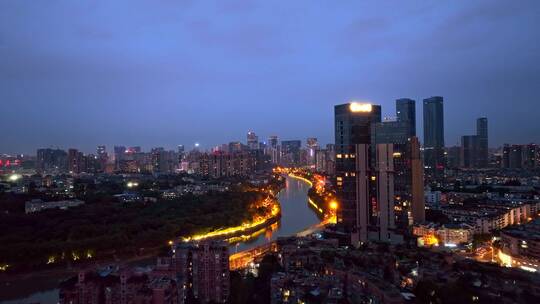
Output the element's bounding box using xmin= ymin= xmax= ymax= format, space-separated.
xmin=423 ymin=96 xmax=445 ymax=181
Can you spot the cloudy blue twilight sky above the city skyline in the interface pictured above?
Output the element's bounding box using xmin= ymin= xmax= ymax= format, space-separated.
xmin=0 ymin=0 xmax=540 ymax=153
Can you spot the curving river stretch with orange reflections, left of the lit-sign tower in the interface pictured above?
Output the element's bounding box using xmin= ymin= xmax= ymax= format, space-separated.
xmin=231 ymin=177 xmax=320 ymax=253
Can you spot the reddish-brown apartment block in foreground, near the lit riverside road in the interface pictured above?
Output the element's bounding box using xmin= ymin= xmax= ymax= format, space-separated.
xmin=172 ymin=242 xmax=230 ymax=303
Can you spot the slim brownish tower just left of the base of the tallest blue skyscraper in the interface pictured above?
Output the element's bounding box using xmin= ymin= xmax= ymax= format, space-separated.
xmin=410 ymin=136 xmax=426 ymax=223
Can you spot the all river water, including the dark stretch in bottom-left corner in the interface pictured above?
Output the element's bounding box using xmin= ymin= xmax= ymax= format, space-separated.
xmin=0 ymin=177 xmax=320 ymax=304
